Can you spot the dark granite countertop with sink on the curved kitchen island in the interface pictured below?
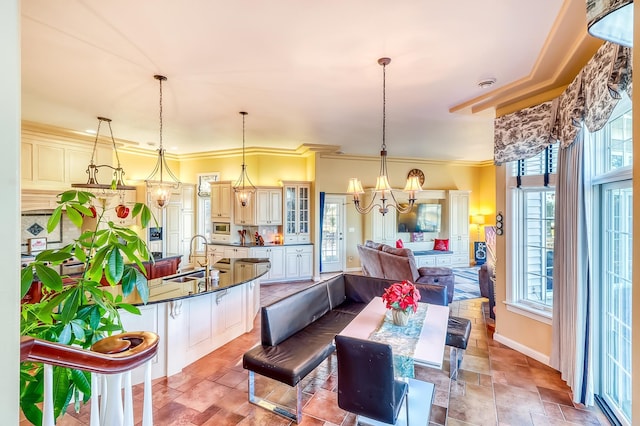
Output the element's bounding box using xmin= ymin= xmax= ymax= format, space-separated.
xmin=105 ymin=258 xmax=271 ymax=305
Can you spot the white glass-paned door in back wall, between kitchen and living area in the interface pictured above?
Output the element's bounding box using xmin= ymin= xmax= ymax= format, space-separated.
xmin=320 ymin=195 xmax=346 ymax=272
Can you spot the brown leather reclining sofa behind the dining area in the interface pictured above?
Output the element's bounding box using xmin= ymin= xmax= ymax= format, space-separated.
xmin=357 ymin=240 xmax=455 ymax=303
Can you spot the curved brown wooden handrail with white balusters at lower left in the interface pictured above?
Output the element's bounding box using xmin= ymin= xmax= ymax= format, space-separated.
xmin=20 ymin=331 xmax=158 ymax=426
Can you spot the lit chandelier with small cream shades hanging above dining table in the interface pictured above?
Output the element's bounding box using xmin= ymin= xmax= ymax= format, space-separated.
xmin=347 ymin=58 xmax=422 ymax=216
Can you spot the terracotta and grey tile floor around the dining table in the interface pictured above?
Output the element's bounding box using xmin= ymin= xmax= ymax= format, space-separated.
xmin=51 ymin=282 xmax=608 ymax=426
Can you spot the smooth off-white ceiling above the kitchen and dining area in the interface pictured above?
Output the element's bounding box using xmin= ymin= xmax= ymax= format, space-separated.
xmin=21 ymin=0 xmax=563 ymax=160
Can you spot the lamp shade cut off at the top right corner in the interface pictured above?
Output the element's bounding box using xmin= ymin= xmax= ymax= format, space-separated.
xmin=587 ymin=0 xmax=633 ymax=47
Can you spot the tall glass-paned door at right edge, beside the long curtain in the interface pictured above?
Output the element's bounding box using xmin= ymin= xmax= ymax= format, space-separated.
xmin=596 ymin=180 xmax=633 ymax=424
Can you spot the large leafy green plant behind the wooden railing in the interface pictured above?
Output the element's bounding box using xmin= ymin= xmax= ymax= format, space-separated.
xmin=20 ymin=190 xmax=152 ymax=425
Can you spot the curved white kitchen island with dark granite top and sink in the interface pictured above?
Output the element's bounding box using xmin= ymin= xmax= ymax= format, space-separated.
xmin=111 ymin=258 xmax=270 ymax=383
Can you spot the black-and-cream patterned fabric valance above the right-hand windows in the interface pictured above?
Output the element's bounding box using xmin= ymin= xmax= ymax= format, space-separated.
xmin=494 ymin=43 xmax=632 ymax=164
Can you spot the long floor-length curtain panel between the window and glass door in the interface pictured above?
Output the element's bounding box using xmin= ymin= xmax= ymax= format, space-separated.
xmin=550 ymin=131 xmax=593 ymax=405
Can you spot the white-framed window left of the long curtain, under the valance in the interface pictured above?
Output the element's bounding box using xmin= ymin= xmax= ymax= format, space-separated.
xmin=507 ymin=144 xmax=558 ymax=322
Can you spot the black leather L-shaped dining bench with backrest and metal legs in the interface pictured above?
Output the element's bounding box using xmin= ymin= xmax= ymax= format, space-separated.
xmin=242 ymin=274 xmax=447 ymax=423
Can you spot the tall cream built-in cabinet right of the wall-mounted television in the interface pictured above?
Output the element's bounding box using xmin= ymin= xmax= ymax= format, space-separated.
xmin=447 ymin=191 xmax=470 ymax=267
